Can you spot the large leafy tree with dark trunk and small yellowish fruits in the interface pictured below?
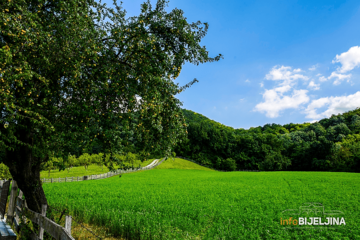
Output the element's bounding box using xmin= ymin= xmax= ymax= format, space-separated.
xmin=0 ymin=0 xmax=222 ymax=212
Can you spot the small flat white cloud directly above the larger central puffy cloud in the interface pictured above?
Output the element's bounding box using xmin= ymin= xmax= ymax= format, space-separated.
xmin=265 ymin=66 xmax=309 ymax=82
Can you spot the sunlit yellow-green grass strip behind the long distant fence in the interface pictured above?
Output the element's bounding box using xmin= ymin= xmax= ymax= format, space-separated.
xmin=40 ymin=159 xmax=155 ymax=178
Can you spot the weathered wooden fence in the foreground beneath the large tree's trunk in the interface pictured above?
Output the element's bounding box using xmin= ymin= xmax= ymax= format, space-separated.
xmin=0 ymin=180 xmax=75 ymax=240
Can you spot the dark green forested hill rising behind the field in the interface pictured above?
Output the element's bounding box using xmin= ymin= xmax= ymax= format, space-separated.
xmin=175 ymin=108 xmax=360 ymax=172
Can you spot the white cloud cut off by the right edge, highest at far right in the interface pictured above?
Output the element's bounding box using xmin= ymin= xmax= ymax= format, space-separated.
xmin=332 ymin=46 xmax=360 ymax=73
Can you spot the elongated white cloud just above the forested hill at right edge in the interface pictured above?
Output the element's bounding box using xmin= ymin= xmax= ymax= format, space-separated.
xmin=305 ymin=91 xmax=360 ymax=119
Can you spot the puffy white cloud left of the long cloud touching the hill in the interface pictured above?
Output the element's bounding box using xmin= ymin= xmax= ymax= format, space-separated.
xmin=254 ymin=86 xmax=309 ymax=118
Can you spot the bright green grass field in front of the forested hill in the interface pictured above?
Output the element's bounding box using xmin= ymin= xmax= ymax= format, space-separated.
xmin=43 ymin=159 xmax=360 ymax=239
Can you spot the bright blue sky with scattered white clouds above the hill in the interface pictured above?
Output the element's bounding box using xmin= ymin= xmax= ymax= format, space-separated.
xmin=101 ymin=0 xmax=360 ymax=129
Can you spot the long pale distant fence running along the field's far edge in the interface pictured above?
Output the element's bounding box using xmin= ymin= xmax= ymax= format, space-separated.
xmin=41 ymin=158 xmax=165 ymax=183
